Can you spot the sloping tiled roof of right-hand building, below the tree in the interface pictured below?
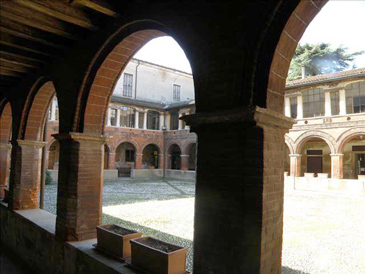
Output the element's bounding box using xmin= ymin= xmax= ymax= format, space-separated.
xmin=286 ymin=68 xmax=365 ymax=88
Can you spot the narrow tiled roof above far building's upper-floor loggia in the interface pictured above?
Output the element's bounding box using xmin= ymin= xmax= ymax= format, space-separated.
xmin=111 ymin=95 xmax=191 ymax=110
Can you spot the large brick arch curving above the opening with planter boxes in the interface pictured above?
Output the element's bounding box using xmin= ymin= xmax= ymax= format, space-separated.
xmin=73 ymin=21 xmax=169 ymax=135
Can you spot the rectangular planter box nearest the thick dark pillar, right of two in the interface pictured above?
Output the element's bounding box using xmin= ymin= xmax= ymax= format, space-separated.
xmin=131 ymin=237 xmax=188 ymax=274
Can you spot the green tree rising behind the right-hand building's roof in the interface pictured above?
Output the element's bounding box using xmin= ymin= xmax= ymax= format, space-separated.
xmin=288 ymin=43 xmax=365 ymax=81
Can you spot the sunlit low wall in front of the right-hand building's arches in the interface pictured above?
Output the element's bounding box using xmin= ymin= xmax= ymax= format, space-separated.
xmin=284 ymin=176 xmax=365 ymax=196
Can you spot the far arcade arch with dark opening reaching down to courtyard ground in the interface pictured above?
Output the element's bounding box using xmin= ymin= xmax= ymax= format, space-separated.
xmin=115 ymin=142 xmax=136 ymax=177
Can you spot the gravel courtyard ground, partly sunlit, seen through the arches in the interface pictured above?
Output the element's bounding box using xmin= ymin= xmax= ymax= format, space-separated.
xmin=45 ymin=179 xmax=365 ymax=274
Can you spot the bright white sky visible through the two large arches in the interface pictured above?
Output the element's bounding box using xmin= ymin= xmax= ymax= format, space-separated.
xmin=134 ymin=0 xmax=365 ymax=73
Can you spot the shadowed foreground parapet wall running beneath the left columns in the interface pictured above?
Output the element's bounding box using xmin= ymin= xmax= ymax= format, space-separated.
xmin=0 ymin=203 xmax=136 ymax=274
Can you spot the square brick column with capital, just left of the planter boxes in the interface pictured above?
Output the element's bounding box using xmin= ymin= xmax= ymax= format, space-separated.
xmin=53 ymin=133 xmax=106 ymax=241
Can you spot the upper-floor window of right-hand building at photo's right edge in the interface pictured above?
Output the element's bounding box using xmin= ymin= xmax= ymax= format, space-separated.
xmin=345 ymin=81 xmax=365 ymax=113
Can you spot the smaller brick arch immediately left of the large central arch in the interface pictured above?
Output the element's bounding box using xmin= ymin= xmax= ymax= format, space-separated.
xmin=19 ymin=78 xmax=56 ymax=141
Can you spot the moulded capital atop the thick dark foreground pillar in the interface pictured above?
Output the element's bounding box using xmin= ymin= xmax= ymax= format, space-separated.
xmin=180 ymin=106 xmax=295 ymax=129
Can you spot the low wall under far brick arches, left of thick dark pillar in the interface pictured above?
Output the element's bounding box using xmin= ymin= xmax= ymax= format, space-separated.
xmin=131 ymin=169 xmax=195 ymax=180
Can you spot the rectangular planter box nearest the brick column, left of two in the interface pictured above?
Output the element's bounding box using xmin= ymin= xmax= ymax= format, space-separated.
xmin=96 ymin=225 xmax=142 ymax=259
